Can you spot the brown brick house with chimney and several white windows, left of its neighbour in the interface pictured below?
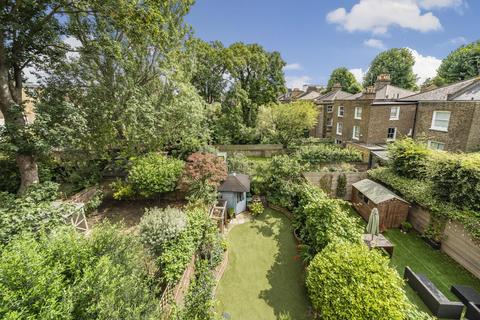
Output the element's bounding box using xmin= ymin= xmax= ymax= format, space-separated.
xmin=326 ymin=75 xmax=416 ymax=144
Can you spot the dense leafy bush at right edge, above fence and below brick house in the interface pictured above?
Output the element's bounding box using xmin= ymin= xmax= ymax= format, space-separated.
xmin=431 ymin=152 xmax=480 ymax=211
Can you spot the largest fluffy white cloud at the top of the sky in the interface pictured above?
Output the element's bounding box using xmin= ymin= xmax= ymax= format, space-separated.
xmin=327 ymin=0 xmax=442 ymax=34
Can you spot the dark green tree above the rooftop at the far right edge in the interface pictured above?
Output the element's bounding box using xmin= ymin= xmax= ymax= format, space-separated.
xmin=434 ymin=40 xmax=480 ymax=85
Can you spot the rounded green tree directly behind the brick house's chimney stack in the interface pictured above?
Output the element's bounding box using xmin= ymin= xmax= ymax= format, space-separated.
xmin=363 ymin=48 xmax=417 ymax=90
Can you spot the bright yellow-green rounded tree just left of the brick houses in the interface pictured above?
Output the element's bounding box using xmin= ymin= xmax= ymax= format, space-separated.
xmin=258 ymin=101 xmax=318 ymax=146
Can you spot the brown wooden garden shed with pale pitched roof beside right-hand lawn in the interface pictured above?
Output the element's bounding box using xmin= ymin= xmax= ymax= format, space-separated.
xmin=352 ymin=179 xmax=410 ymax=232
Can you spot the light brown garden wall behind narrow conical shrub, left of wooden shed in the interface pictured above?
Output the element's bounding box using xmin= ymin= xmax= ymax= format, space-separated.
xmin=303 ymin=172 xmax=367 ymax=200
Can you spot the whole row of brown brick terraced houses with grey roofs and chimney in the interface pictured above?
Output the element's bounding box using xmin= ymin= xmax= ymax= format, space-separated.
xmin=311 ymin=74 xmax=480 ymax=151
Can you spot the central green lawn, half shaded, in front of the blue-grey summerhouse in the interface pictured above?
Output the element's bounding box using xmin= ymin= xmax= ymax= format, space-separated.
xmin=217 ymin=209 xmax=310 ymax=320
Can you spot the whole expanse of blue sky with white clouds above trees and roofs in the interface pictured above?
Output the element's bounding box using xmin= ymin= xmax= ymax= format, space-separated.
xmin=187 ymin=0 xmax=480 ymax=87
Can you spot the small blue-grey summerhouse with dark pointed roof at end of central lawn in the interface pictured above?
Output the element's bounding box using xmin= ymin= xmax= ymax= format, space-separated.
xmin=218 ymin=173 xmax=250 ymax=214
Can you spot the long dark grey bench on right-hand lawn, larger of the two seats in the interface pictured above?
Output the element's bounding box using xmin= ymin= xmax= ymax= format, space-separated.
xmin=403 ymin=267 xmax=463 ymax=319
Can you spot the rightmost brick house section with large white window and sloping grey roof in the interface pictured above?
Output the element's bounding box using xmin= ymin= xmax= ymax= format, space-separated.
xmin=400 ymin=77 xmax=480 ymax=152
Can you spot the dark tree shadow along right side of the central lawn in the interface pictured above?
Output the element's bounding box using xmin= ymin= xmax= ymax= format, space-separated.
xmin=251 ymin=211 xmax=312 ymax=319
